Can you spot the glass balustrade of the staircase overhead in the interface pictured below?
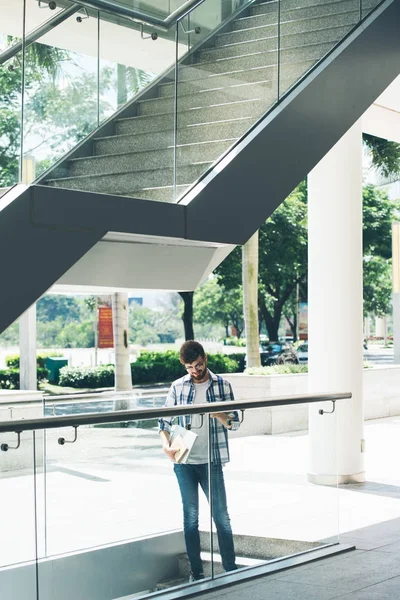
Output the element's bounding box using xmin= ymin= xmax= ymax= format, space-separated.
xmin=0 ymin=0 xmax=388 ymax=202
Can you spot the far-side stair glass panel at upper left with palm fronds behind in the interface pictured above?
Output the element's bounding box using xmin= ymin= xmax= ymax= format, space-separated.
xmin=23 ymin=3 xmax=101 ymax=183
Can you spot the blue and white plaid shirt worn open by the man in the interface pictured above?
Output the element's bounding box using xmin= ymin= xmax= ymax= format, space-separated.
xmin=158 ymin=370 xmax=240 ymax=464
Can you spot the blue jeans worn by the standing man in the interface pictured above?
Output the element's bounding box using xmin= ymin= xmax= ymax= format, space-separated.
xmin=174 ymin=464 xmax=237 ymax=577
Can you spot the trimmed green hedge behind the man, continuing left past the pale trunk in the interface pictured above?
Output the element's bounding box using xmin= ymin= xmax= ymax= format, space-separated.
xmin=59 ymin=350 xmax=244 ymax=388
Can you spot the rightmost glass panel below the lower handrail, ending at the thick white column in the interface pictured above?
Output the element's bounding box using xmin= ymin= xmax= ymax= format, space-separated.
xmin=212 ymin=403 xmax=338 ymax=575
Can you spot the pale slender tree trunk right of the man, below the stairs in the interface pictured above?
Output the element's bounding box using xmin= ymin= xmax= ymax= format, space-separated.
xmin=242 ymin=231 xmax=261 ymax=367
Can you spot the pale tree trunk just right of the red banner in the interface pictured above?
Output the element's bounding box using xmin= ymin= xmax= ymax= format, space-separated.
xmin=112 ymin=292 xmax=132 ymax=410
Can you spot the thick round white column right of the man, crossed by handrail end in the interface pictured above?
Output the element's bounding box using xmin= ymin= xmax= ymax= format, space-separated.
xmin=308 ymin=122 xmax=365 ymax=485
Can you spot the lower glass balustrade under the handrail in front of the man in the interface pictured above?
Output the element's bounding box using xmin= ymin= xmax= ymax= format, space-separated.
xmin=0 ymin=397 xmax=339 ymax=600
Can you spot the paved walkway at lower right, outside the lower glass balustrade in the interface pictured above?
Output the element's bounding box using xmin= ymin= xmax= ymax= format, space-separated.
xmin=202 ymin=417 xmax=400 ymax=600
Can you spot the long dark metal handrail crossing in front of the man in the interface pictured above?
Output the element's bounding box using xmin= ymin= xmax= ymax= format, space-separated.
xmin=0 ymin=392 xmax=352 ymax=433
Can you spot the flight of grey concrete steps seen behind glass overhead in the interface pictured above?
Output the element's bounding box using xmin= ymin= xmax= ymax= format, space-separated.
xmin=40 ymin=0 xmax=378 ymax=202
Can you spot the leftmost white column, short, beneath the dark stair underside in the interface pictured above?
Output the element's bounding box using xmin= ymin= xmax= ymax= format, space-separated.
xmin=19 ymin=304 xmax=37 ymax=390
